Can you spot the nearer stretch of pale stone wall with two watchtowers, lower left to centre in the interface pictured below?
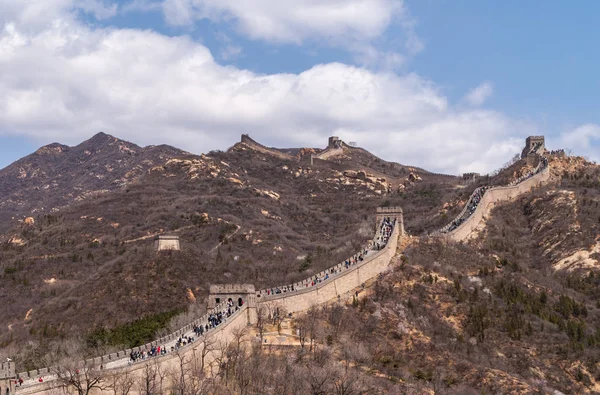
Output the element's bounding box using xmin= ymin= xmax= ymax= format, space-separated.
xmin=14 ymin=217 xmax=402 ymax=395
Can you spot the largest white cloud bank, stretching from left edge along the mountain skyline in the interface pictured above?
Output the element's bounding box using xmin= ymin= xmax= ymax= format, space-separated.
xmin=0 ymin=2 xmax=535 ymax=173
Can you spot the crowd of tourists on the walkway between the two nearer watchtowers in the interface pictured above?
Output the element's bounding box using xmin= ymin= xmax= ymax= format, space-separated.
xmin=259 ymin=217 xmax=396 ymax=297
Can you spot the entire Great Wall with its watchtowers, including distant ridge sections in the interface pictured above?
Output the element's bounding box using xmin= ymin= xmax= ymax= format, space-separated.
xmin=5 ymin=136 xmax=550 ymax=395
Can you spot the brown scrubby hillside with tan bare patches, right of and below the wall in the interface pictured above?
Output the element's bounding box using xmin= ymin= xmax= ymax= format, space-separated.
xmin=261 ymin=155 xmax=600 ymax=394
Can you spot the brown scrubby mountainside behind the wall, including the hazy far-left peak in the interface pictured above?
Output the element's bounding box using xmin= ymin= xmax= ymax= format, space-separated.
xmin=0 ymin=135 xmax=464 ymax=366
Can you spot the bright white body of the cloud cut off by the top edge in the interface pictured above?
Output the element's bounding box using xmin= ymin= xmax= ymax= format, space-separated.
xmin=163 ymin=0 xmax=402 ymax=43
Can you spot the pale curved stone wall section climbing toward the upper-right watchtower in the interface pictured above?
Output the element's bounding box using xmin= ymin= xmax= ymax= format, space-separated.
xmin=444 ymin=166 xmax=550 ymax=241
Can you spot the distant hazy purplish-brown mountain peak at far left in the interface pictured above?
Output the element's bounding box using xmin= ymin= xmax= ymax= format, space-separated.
xmin=0 ymin=133 xmax=186 ymax=231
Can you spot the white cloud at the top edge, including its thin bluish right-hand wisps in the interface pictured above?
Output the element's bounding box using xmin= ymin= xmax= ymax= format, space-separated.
xmin=163 ymin=0 xmax=424 ymax=69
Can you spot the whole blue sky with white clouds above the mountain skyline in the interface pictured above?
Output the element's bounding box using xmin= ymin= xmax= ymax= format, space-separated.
xmin=0 ymin=0 xmax=600 ymax=173
